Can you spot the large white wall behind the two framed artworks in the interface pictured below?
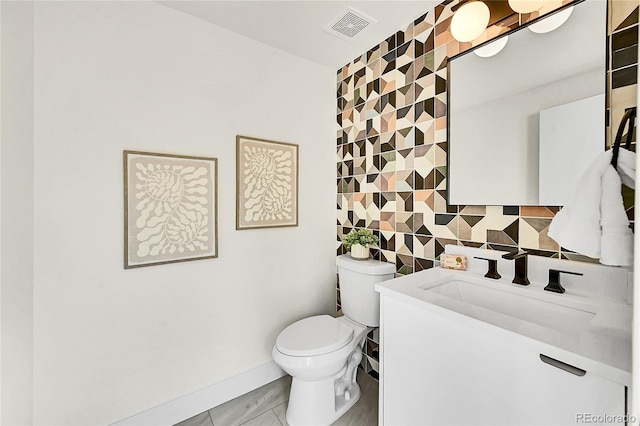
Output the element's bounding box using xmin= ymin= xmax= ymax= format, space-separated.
xmin=34 ymin=2 xmax=335 ymax=425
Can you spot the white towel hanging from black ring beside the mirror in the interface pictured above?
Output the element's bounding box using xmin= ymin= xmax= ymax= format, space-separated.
xmin=549 ymin=148 xmax=635 ymax=266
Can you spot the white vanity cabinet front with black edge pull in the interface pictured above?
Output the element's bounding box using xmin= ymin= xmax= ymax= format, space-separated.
xmin=380 ymin=296 xmax=625 ymax=426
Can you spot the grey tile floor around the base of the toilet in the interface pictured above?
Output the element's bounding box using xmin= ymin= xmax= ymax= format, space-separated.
xmin=176 ymin=369 xmax=378 ymax=426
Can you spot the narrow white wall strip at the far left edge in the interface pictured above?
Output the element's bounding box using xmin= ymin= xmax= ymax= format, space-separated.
xmin=0 ymin=1 xmax=34 ymax=425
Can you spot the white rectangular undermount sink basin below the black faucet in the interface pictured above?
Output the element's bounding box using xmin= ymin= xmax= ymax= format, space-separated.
xmin=421 ymin=278 xmax=597 ymax=332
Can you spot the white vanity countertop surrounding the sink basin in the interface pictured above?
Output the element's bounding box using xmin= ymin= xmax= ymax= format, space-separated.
xmin=376 ymin=266 xmax=632 ymax=386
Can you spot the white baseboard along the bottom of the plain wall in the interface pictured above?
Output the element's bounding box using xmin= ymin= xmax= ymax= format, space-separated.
xmin=113 ymin=361 xmax=286 ymax=426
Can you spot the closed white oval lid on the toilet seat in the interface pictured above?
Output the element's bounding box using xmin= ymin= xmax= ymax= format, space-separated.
xmin=276 ymin=315 xmax=353 ymax=356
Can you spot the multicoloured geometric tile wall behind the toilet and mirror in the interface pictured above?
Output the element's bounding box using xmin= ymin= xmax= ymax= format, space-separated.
xmin=336 ymin=0 xmax=638 ymax=376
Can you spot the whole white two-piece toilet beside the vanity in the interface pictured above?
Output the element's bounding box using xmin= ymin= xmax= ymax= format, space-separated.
xmin=273 ymin=254 xmax=396 ymax=426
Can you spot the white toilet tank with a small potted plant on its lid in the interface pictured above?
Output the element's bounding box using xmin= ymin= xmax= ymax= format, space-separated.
xmin=336 ymin=254 xmax=396 ymax=327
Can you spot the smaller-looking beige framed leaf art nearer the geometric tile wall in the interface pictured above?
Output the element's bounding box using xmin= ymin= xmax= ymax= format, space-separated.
xmin=236 ymin=136 xmax=298 ymax=230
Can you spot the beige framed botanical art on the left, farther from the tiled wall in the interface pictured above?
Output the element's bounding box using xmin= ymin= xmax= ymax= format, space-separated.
xmin=123 ymin=151 xmax=218 ymax=269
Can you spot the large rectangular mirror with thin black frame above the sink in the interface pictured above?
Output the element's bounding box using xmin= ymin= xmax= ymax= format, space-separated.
xmin=447 ymin=0 xmax=607 ymax=205
